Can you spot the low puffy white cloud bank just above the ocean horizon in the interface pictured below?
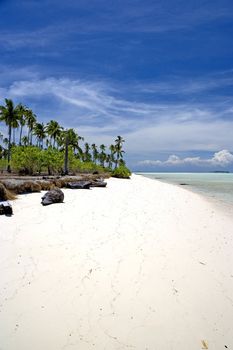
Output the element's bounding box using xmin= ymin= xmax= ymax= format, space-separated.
xmin=138 ymin=150 xmax=233 ymax=167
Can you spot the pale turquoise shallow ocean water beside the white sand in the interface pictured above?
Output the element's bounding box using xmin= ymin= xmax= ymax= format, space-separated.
xmin=138 ymin=173 xmax=233 ymax=205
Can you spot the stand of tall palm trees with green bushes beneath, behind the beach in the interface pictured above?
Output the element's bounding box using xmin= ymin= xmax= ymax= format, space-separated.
xmin=0 ymin=99 xmax=130 ymax=178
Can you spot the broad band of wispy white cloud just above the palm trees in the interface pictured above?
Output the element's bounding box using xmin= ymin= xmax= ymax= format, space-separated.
xmin=0 ymin=72 xmax=233 ymax=165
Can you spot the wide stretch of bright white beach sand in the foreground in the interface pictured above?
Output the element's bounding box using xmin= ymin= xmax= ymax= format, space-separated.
xmin=0 ymin=175 xmax=233 ymax=350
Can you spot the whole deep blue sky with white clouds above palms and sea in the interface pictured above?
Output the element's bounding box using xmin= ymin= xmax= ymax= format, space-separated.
xmin=0 ymin=0 xmax=233 ymax=171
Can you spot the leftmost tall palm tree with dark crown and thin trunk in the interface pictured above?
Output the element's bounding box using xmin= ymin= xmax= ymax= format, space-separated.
xmin=0 ymin=98 xmax=18 ymax=173
